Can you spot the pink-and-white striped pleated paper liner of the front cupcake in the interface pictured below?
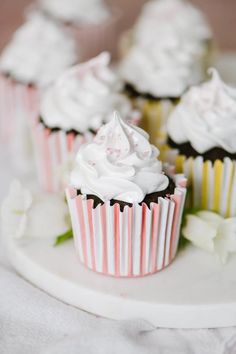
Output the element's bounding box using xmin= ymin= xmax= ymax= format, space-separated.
xmin=66 ymin=176 xmax=186 ymax=278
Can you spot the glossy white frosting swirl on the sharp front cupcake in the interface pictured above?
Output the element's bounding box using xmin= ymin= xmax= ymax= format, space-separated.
xmin=70 ymin=114 xmax=169 ymax=203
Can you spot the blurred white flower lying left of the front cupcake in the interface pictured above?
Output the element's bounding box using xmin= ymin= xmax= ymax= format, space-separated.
xmin=2 ymin=181 xmax=71 ymax=238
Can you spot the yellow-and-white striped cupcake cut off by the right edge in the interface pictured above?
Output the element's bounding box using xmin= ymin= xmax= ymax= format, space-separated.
xmin=166 ymin=69 xmax=236 ymax=217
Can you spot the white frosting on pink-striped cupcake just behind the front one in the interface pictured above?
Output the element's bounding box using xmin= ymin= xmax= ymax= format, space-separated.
xmin=40 ymin=52 xmax=132 ymax=133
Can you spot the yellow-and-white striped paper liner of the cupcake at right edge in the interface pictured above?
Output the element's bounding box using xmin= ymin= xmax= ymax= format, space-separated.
xmin=165 ymin=149 xmax=236 ymax=217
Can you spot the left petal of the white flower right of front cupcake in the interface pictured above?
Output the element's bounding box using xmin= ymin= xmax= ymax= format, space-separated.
xmin=182 ymin=215 xmax=217 ymax=252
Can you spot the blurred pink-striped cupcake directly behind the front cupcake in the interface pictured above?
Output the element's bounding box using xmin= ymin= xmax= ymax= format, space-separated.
xmin=33 ymin=52 xmax=139 ymax=192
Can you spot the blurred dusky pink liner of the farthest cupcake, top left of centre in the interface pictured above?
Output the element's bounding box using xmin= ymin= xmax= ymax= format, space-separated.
xmin=69 ymin=9 xmax=121 ymax=60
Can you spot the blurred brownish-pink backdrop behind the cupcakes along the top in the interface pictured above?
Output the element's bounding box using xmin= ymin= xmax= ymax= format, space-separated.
xmin=0 ymin=0 xmax=236 ymax=50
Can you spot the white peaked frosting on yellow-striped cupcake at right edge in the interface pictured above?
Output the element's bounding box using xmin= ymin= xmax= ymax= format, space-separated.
xmin=167 ymin=69 xmax=236 ymax=154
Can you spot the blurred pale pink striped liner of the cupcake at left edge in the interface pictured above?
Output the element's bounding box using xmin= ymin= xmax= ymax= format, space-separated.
xmin=0 ymin=75 xmax=39 ymax=144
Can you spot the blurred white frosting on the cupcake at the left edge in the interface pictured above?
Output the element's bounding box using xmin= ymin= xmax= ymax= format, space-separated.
xmin=0 ymin=14 xmax=77 ymax=87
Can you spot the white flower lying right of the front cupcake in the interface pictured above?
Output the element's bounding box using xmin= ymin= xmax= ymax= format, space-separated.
xmin=182 ymin=211 xmax=236 ymax=263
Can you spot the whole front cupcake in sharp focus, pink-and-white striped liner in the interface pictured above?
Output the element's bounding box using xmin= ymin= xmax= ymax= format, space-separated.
xmin=66 ymin=114 xmax=186 ymax=277
